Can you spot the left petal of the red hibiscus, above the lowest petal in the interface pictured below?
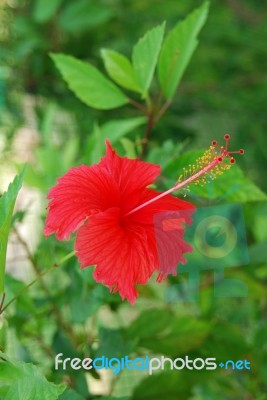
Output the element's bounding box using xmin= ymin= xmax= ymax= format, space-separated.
xmin=44 ymin=165 xmax=120 ymax=239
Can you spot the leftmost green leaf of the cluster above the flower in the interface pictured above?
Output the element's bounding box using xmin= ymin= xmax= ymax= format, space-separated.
xmin=51 ymin=54 xmax=128 ymax=110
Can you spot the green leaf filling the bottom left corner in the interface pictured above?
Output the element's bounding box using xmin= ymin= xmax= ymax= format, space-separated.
xmin=0 ymin=352 xmax=65 ymax=400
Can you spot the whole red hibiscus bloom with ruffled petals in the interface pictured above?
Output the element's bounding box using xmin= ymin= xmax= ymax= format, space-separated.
xmin=44 ymin=141 xmax=194 ymax=303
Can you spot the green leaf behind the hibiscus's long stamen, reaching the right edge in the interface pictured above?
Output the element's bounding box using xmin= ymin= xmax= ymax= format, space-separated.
xmin=164 ymin=151 xmax=267 ymax=203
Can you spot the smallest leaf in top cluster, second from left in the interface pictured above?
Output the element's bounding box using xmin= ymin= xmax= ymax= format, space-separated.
xmin=101 ymin=49 xmax=141 ymax=93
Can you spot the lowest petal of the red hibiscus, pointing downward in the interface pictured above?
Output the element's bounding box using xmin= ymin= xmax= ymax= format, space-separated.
xmin=75 ymin=208 xmax=157 ymax=303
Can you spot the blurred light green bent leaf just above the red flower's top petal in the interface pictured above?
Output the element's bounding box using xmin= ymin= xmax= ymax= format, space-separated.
xmin=87 ymin=117 xmax=146 ymax=163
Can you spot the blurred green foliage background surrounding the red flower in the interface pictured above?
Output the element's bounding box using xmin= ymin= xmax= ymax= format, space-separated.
xmin=0 ymin=0 xmax=267 ymax=400
